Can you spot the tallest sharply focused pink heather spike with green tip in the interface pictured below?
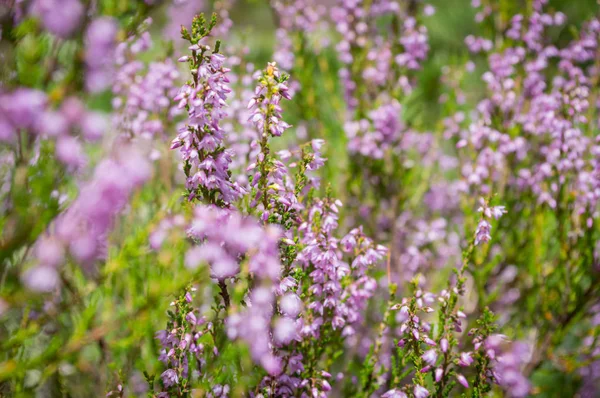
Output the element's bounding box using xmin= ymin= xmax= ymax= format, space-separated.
xmin=171 ymin=15 xmax=244 ymax=207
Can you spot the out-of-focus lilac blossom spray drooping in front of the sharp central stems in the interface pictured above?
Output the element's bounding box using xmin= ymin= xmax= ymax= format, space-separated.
xmin=185 ymin=205 xmax=281 ymax=375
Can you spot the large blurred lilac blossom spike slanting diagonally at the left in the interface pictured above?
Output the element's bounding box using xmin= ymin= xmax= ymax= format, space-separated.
xmin=23 ymin=146 xmax=152 ymax=291
